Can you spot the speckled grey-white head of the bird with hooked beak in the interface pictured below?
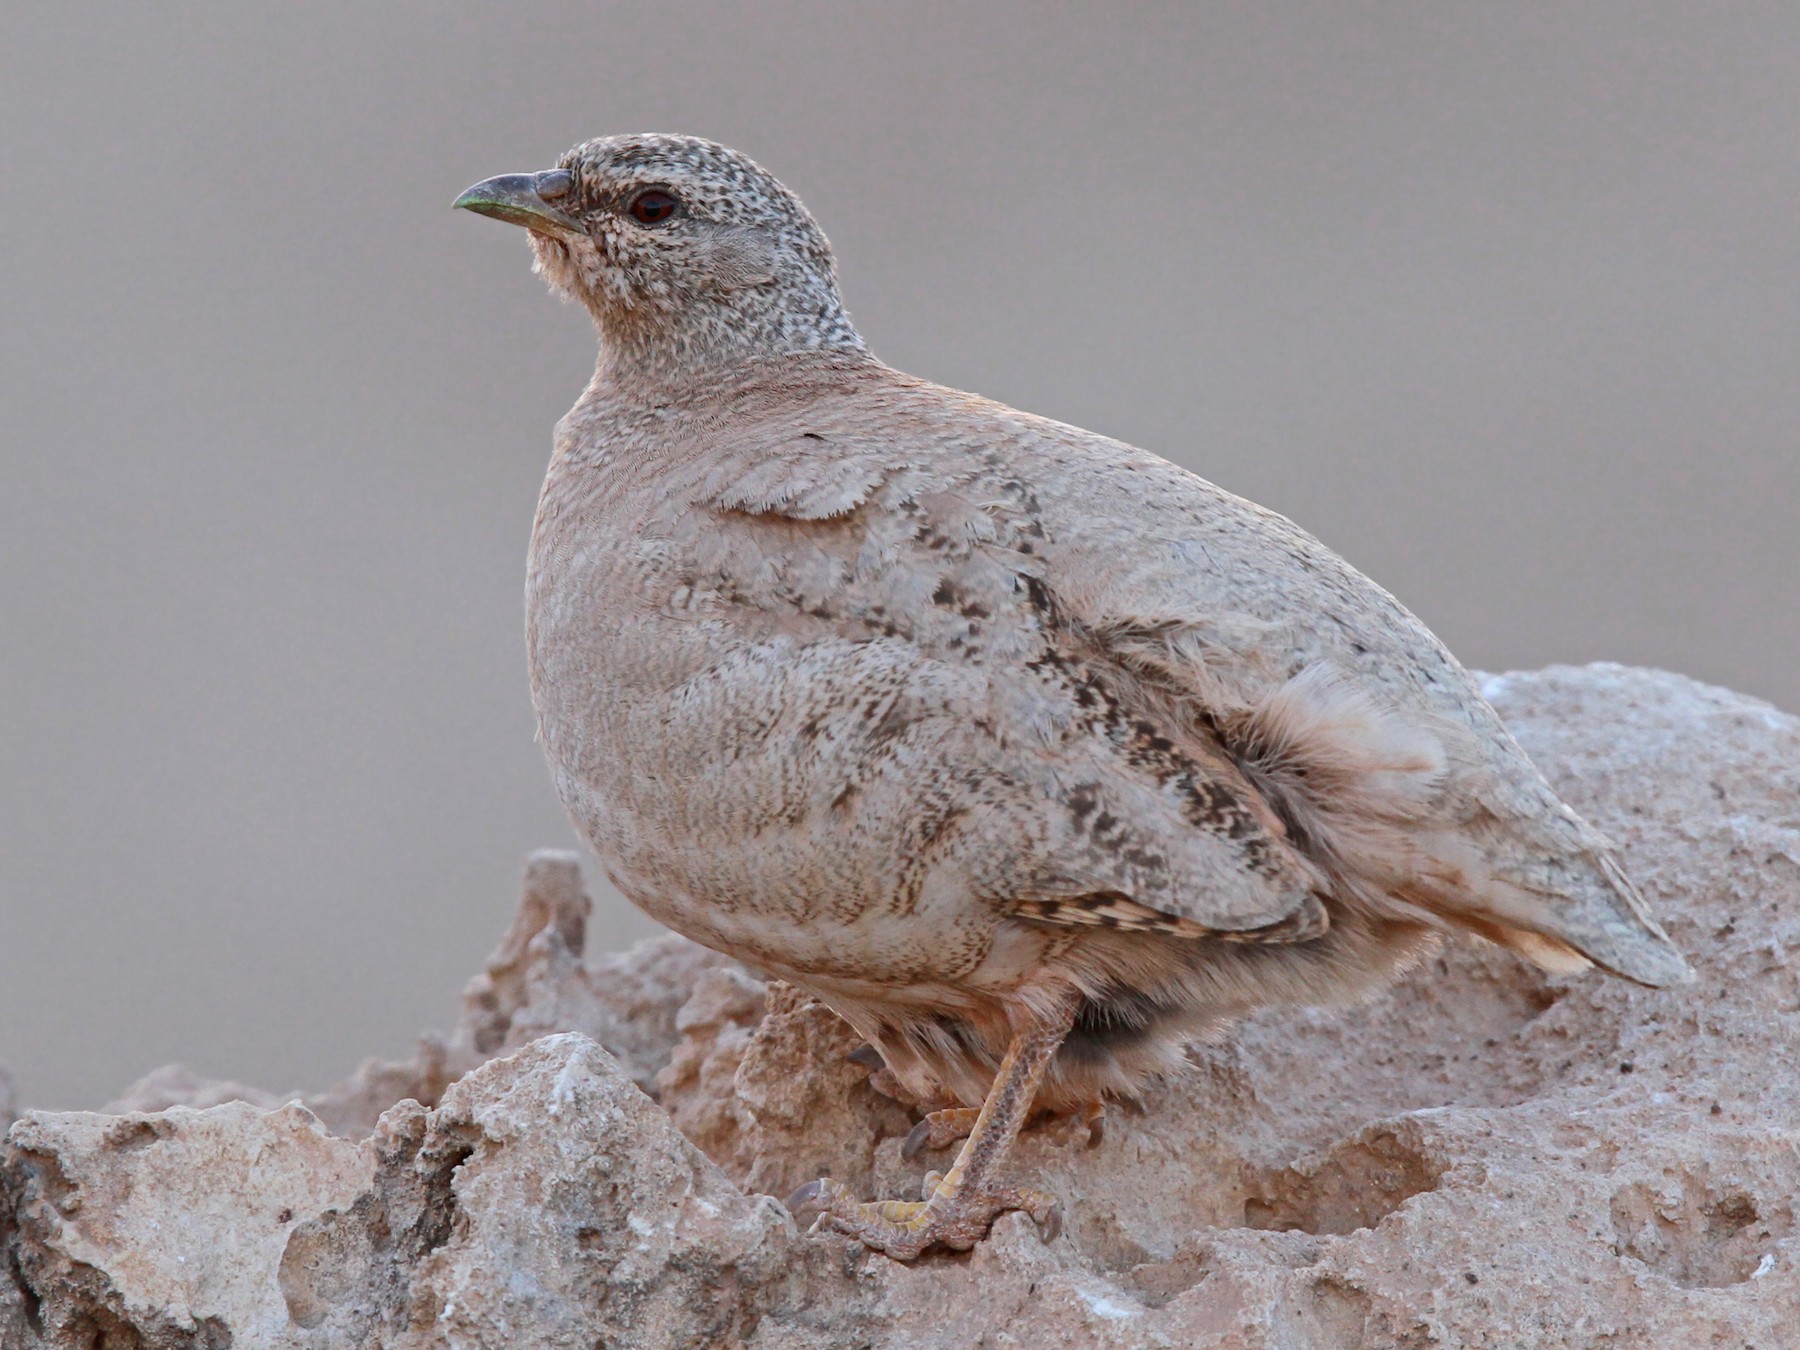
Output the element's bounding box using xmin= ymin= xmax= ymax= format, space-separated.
xmin=455 ymin=135 xmax=862 ymax=383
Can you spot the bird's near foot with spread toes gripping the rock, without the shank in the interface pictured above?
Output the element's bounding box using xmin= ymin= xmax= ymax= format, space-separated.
xmin=788 ymin=1172 xmax=1062 ymax=1262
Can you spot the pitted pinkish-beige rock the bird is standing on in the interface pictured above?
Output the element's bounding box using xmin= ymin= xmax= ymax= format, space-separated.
xmin=0 ymin=666 xmax=1800 ymax=1350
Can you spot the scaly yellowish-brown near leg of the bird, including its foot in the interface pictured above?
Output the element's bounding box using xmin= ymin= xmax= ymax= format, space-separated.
xmin=788 ymin=995 xmax=1076 ymax=1260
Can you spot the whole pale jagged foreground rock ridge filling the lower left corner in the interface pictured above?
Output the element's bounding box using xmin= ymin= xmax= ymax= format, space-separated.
xmin=0 ymin=1033 xmax=794 ymax=1348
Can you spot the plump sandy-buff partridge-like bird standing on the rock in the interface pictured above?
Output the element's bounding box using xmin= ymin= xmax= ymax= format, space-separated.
xmin=455 ymin=133 xmax=1692 ymax=1260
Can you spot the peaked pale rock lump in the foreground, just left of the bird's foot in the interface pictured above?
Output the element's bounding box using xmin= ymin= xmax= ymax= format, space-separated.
xmin=270 ymin=1033 xmax=794 ymax=1348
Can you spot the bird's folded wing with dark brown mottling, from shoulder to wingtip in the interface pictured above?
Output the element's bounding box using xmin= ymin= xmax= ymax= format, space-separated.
xmin=680 ymin=406 xmax=1328 ymax=941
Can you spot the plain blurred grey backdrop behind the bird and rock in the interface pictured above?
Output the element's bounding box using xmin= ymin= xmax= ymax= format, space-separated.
xmin=0 ymin=0 xmax=1800 ymax=1107
